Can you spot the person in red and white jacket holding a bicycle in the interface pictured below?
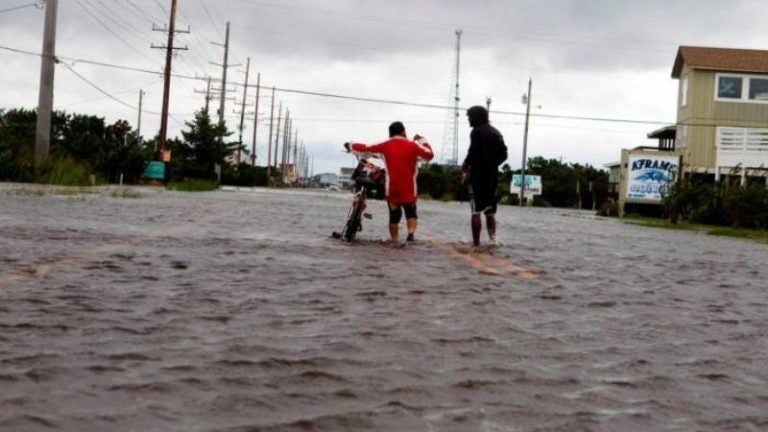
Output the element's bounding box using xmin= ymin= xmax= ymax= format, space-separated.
xmin=350 ymin=122 xmax=434 ymax=243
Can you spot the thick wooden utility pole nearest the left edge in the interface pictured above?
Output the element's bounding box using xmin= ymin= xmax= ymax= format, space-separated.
xmin=35 ymin=0 xmax=59 ymax=164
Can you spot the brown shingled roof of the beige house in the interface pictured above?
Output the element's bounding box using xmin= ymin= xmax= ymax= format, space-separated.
xmin=672 ymin=46 xmax=768 ymax=78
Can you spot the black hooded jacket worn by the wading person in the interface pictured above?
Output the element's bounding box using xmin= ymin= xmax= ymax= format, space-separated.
xmin=462 ymin=106 xmax=507 ymax=184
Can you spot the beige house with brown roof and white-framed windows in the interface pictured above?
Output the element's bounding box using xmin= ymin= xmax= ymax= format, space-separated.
xmin=672 ymin=46 xmax=768 ymax=183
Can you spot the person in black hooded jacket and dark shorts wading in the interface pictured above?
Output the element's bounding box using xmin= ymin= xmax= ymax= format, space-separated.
xmin=461 ymin=106 xmax=507 ymax=247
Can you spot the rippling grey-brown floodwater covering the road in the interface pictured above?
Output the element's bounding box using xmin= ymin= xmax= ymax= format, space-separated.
xmin=0 ymin=185 xmax=768 ymax=432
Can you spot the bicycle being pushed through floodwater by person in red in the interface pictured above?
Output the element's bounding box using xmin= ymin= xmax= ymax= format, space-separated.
xmin=331 ymin=144 xmax=386 ymax=242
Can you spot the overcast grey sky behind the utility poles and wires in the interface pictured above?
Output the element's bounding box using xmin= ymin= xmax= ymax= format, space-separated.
xmin=0 ymin=0 xmax=768 ymax=173
